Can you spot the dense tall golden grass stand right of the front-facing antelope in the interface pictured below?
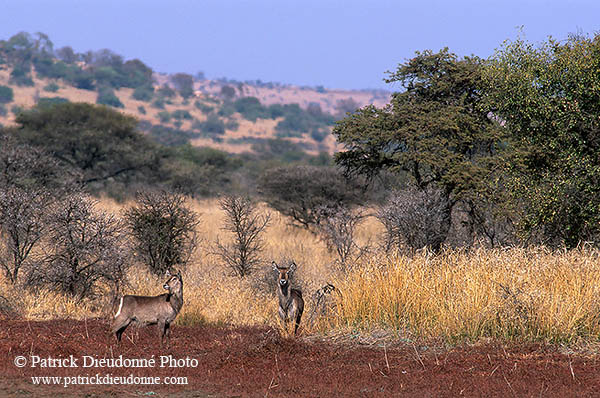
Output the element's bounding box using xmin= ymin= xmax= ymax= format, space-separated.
xmin=333 ymin=248 xmax=600 ymax=343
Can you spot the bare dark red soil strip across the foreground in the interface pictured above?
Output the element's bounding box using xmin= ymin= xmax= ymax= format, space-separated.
xmin=0 ymin=320 xmax=600 ymax=397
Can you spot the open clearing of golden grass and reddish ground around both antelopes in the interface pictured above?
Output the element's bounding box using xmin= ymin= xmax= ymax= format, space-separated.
xmin=0 ymin=200 xmax=600 ymax=396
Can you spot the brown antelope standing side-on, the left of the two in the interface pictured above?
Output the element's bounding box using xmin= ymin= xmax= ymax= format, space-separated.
xmin=112 ymin=271 xmax=183 ymax=346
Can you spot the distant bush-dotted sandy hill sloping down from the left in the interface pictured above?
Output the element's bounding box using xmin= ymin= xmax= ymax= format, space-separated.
xmin=0 ymin=33 xmax=390 ymax=154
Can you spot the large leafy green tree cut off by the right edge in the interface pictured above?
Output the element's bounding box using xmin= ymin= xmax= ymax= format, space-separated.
xmin=484 ymin=35 xmax=600 ymax=247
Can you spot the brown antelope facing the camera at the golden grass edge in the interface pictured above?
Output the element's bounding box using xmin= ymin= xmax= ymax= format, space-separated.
xmin=272 ymin=261 xmax=304 ymax=334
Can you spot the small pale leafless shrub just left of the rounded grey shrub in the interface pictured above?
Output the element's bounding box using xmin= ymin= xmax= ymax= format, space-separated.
xmin=319 ymin=207 xmax=365 ymax=270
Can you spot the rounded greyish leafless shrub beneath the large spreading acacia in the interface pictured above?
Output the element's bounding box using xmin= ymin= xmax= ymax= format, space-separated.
xmin=376 ymin=188 xmax=451 ymax=251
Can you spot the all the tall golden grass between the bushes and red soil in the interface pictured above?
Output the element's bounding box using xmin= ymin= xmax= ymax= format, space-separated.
xmin=2 ymin=200 xmax=600 ymax=344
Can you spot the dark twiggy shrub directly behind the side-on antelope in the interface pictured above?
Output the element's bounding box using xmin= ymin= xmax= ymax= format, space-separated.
xmin=124 ymin=191 xmax=200 ymax=276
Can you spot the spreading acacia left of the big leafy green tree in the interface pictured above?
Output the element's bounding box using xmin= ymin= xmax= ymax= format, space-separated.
xmin=333 ymin=49 xmax=498 ymax=247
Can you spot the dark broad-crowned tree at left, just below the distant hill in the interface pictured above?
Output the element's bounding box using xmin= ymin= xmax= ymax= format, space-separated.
xmin=15 ymin=103 xmax=155 ymax=188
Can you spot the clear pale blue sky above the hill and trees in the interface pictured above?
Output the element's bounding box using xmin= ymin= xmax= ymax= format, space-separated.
xmin=0 ymin=0 xmax=600 ymax=89
